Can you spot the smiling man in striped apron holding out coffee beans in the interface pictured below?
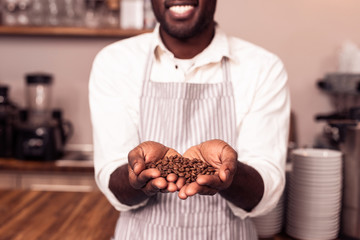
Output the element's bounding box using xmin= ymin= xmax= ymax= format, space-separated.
xmin=89 ymin=0 xmax=290 ymax=240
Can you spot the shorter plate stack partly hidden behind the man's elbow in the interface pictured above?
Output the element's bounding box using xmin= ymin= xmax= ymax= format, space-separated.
xmin=253 ymin=195 xmax=285 ymax=238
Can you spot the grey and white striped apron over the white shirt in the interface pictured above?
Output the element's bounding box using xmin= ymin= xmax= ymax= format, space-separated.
xmin=115 ymin=53 xmax=257 ymax=240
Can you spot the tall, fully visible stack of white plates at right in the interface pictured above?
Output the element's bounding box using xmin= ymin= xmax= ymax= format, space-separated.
xmin=286 ymin=149 xmax=342 ymax=240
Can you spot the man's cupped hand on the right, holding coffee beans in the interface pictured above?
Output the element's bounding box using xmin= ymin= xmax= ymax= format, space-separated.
xmin=176 ymin=139 xmax=237 ymax=199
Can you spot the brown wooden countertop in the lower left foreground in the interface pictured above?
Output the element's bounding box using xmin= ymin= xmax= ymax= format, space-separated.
xmin=0 ymin=190 xmax=119 ymax=240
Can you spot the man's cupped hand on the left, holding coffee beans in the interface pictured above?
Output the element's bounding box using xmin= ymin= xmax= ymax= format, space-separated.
xmin=128 ymin=141 xmax=180 ymax=196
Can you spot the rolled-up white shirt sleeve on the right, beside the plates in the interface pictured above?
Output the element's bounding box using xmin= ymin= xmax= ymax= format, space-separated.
xmin=228 ymin=55 xmax=290 ymax=218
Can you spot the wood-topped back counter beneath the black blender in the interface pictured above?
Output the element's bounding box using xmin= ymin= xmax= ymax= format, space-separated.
xmin=0 ymin=158 xmax=97 ymax=191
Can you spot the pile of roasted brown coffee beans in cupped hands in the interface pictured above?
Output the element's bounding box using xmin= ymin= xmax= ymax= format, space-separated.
xmin=146 ymin=155 xmax=216 ymax=183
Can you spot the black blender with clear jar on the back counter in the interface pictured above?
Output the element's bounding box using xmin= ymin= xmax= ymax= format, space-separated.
xmin=14 ymin=73 xmax=73 ymax=161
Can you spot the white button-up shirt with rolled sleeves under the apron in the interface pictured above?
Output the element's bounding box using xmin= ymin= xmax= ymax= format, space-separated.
xmin=89 ymin=24 xmax=290 ymax=218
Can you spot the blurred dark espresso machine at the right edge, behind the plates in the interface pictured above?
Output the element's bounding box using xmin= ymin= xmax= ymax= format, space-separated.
xmin=316 ymin=73 xmax=360 ymax=239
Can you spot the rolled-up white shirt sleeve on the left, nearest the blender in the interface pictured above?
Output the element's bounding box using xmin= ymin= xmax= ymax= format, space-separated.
xmin=89 ymin=46 xmax=146 ymax=211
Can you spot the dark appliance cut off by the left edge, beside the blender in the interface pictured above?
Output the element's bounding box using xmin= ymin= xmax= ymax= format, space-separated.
xmin=0 ymin=85 xmax=16 ymax=157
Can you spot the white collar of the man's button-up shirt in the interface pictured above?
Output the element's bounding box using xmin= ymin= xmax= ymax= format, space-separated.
xmin=151 ymin=24 xmax=231 ymax=66
